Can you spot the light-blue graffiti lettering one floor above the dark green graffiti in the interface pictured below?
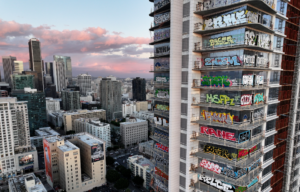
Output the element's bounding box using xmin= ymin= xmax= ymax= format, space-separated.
xmin=204 ymin=56 xmax=241 ymax=66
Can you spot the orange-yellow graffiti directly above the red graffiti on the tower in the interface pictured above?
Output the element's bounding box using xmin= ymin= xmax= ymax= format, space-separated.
xmin=201 ymin=110 xmax=234 ymax=124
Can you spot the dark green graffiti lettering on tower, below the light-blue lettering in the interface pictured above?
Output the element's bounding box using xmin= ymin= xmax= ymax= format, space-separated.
xmin=201 ymin=75 xmax=232 ymax=87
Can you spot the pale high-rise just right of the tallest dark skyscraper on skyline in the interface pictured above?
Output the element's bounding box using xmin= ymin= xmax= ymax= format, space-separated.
xmin=53 ymin=55 xmax=73 ymax=86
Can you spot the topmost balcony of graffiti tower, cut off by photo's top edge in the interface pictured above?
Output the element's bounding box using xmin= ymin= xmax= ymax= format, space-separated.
xmin=194 ymin=0 xmax=276 ymax=15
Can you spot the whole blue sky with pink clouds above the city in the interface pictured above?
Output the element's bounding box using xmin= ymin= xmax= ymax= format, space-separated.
xmin=0 ymin=0 xmax=153 ymax=78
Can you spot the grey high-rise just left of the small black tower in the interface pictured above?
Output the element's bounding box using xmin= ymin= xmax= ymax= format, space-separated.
xmin=100 ymin=78 xmax=122 ymax=120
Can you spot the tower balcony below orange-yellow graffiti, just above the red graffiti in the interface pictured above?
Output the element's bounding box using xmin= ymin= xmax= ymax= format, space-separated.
xmin=191 ymin=116 xmax=266 ymax=130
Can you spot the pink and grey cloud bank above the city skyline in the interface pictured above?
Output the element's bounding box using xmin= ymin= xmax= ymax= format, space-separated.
xmin=0 ymin=19 xmax=153 ymax=77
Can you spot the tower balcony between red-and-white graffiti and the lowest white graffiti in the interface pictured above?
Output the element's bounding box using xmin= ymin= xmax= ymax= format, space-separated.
xmin=191 ymin=163 xmax=262 ymax=186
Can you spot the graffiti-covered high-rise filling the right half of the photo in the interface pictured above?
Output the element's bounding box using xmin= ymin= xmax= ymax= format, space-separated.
xmin=149 ymin=0 xmax=300 ymax=192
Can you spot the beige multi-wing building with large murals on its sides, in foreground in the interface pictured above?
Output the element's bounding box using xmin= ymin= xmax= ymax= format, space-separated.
xmin=44 ymin=133 xmax=106 ymax=192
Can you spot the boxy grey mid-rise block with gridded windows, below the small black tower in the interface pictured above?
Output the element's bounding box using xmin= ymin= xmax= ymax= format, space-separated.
xmin=120 ymin=117 xmax=148 ymax=148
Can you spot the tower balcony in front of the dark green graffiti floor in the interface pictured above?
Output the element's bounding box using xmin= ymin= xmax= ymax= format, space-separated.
xmin=192 ymin=78 xmax=269 ymax=91
